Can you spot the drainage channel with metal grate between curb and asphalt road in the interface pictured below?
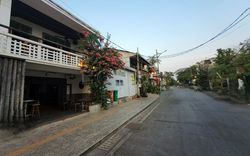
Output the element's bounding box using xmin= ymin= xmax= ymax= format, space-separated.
xmin=83 ymin=99 xmax=160 ymax=156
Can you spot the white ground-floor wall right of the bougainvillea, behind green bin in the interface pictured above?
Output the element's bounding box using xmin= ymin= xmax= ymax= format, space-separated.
xmin=107 ymin=70 xmax=136 ymax=98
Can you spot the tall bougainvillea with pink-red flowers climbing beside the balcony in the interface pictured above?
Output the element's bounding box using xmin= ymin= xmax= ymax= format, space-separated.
xmin=80 ymin=31 xmax=124 ymax=108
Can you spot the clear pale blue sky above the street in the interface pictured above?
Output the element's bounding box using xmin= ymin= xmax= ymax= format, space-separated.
xmin=54 ymin=0 xmax=250 ymax=72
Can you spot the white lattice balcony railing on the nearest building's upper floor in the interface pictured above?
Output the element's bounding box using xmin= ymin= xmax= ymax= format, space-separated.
xmin=0 ymin=32 xmax=83 ymax=69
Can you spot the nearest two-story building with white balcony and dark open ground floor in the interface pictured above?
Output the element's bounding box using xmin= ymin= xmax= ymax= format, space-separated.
xmin=0 ymin=0 xmax=97 ymax=122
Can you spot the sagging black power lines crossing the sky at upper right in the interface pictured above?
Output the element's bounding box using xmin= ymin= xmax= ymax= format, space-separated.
xmin=161 ymin=7 xmax=250 ymax=58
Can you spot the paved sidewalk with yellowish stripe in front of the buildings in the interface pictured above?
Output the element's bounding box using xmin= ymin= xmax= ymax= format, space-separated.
xmin=0 ymin=94 xmax=159 ymax=156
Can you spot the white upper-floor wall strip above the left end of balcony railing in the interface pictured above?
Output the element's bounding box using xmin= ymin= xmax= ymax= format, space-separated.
xmin=0 ymin=0 xmax=12 ymax=32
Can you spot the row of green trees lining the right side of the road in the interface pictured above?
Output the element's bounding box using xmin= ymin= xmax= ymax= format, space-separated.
xmin=177 ymin=39 xmax=250 ymax=100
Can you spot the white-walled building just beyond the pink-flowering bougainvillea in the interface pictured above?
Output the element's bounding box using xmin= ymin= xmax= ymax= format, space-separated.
xmin=108 ymin=50 xmax=149 ymax=100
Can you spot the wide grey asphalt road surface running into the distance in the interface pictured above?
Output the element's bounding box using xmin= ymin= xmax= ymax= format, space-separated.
xmin=114 ymin=88 xmax=250 ymax=156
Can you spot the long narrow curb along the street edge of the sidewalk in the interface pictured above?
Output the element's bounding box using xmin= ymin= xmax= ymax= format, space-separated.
xmin=79 ymin=96 xmax=160 ymax=156
